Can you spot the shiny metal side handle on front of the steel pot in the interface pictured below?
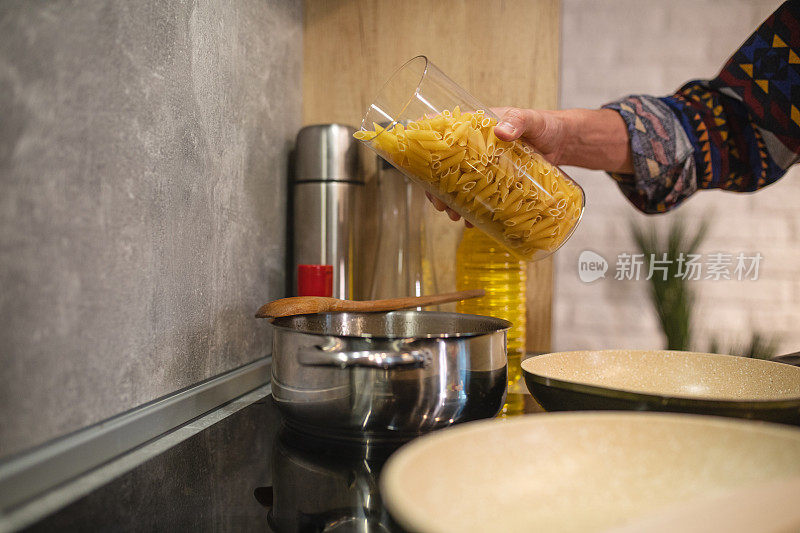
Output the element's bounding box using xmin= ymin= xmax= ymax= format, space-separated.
xmin=297 ymin=346 xmax=430 ymax=368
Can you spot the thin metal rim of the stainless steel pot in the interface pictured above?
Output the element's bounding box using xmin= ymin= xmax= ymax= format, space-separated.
xmin=269 ymin=309 xmax=512 ymax=340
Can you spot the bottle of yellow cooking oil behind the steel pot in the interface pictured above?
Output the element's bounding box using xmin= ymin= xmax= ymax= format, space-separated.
xmin=456 ymin=228 xmax=527 ymax=417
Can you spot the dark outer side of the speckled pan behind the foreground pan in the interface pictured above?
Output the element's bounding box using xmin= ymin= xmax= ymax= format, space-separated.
xmin=522 ymin=368 xmax=800 ymax=410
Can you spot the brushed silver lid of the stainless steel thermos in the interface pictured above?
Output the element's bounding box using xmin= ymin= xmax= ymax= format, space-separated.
xmin=293 ymin=124 xmax=364 ymax=183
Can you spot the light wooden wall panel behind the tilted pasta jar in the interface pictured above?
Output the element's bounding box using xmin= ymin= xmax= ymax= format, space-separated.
xmin=303 ymin=0 xmax=560 ymax=351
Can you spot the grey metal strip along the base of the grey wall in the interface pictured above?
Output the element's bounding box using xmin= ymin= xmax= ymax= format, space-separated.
xmin=0 ymin=357 xmax=271 ymax=515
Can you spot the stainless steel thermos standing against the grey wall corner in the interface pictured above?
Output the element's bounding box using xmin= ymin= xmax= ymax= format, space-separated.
xmin=290 ymin=124 xmax=364 ymax=299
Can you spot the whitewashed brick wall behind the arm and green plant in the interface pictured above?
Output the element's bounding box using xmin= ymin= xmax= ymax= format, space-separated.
xmin=554 ymin=0 xmax=800 ymax=352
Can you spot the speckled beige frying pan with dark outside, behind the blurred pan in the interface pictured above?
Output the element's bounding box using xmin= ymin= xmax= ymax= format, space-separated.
xmin=522 ymin=350 xmax=800 ymax=425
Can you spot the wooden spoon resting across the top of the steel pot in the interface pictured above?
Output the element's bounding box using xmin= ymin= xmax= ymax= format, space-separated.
xmin=256 ymin=289 xmax=486 ymax=318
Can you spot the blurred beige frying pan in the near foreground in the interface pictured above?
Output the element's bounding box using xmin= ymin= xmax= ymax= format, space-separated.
xmin=380 ymin=412 xmax=800 ymax=533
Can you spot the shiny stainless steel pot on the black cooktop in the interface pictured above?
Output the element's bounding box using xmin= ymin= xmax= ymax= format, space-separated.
xmin=272 ymin=311 xmax=511 ymax=440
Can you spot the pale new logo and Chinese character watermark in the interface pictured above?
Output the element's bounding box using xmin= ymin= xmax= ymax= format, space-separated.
xmin=578 ymin=250 xmax=764 ymax=283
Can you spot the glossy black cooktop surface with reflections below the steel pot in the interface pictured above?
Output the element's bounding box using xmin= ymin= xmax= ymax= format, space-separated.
xmin=25 ymin=397 xmax=410 ymax=533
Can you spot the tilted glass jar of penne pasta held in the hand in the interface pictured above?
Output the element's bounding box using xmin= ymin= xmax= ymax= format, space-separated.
xmin=355 ymin=56 xmax=584 ymax=261
